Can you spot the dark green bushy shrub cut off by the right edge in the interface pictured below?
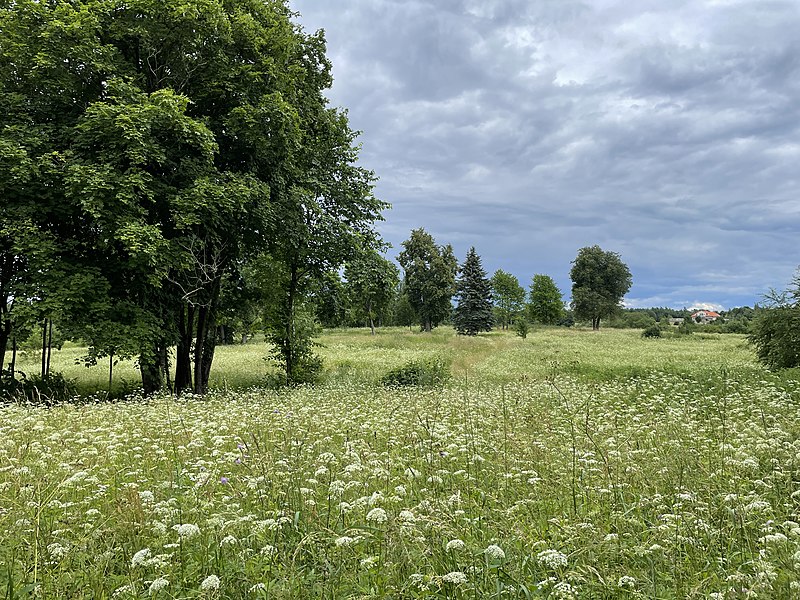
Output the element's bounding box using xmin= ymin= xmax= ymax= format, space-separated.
xmin=748 ymin=272 xmax=800 ymax=369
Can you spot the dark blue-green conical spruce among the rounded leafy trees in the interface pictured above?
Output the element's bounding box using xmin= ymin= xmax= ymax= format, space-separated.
xmin=453 ymin=246 xmax=494 ymax=335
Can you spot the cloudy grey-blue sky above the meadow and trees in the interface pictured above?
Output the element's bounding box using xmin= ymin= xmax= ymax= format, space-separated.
xmin=291 ymin=0 xmax=800 ymax=309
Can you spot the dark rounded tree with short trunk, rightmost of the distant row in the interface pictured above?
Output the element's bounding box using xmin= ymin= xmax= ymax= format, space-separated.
xmin=569 ymin=246 xmax=632 ymax=331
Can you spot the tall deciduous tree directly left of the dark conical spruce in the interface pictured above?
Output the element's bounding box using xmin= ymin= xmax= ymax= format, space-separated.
xmin=398 ymin=228 xmax=458 ymax=332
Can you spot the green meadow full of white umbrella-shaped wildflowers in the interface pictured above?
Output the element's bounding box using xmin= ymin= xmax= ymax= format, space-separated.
xmin=0 ymin=329 xmax=800 ymax=599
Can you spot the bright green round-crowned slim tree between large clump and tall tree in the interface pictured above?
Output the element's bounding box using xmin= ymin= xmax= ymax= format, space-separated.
xmin=344 ymin=249 xmax=399 ymax=335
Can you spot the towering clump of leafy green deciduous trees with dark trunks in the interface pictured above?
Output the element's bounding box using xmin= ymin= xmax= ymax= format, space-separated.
xmin=0 ymin=0 xmax=384 ymax=393
